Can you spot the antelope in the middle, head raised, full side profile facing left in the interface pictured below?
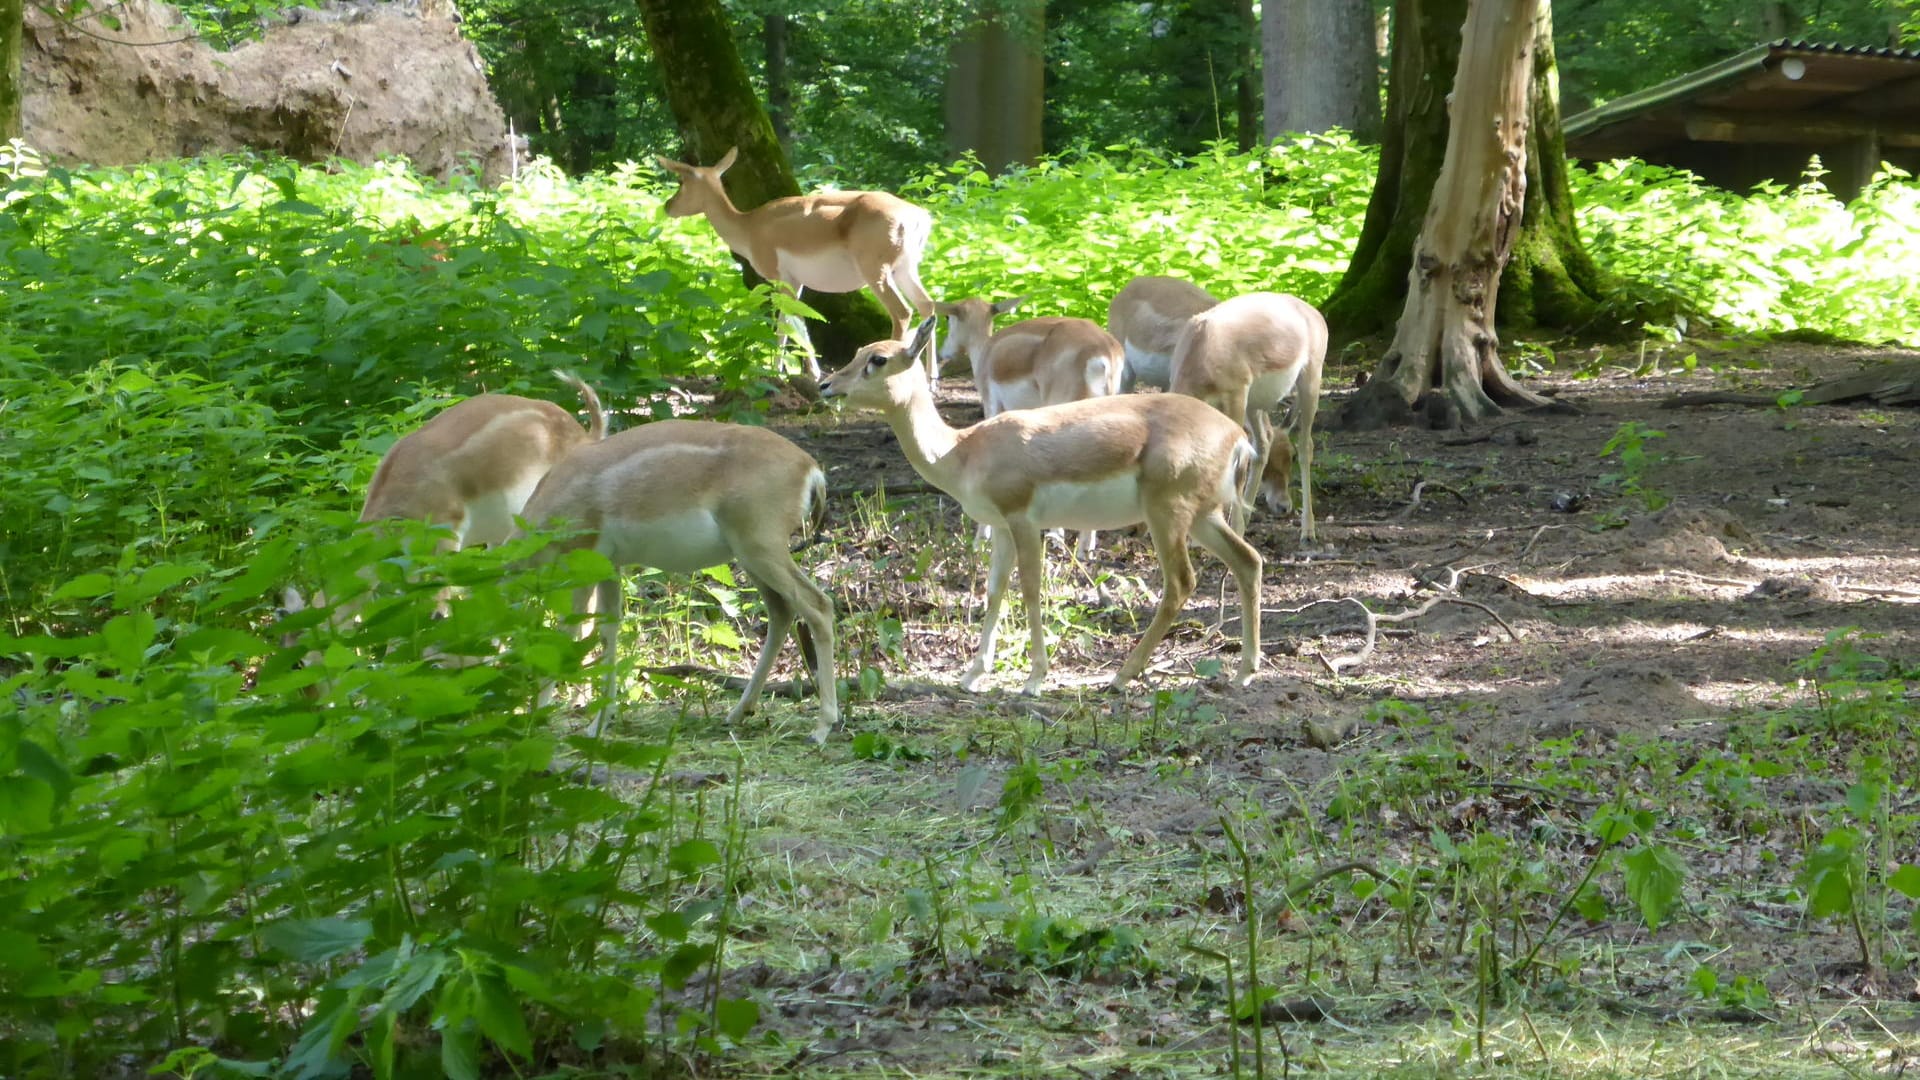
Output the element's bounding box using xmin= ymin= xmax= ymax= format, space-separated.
xmin=820 ymin=319 xmax=1261 ymax=694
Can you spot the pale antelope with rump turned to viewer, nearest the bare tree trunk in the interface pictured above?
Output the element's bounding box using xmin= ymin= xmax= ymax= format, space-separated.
xmin=1169 ymin=292 xmax=1327 ymax=544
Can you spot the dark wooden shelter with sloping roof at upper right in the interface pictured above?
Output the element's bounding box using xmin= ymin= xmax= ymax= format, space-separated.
xmin=1565 ymin=40 xmax=1920 ymax=198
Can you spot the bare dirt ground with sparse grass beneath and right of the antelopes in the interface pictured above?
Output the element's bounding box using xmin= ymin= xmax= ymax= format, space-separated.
xmin=652 ymin=344 xmax=1920 ymax=1078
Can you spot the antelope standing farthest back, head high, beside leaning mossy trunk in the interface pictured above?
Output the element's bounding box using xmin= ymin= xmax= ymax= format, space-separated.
xmin=655 ymin=146 xmax=939 ymax=380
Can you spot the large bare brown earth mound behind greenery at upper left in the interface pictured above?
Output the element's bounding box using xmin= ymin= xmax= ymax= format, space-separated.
xmin=21 ymin=0 xmax=513 ymax=179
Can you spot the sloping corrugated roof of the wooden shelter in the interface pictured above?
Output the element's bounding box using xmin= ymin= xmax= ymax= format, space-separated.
xmin=1565 ymin=38 xmax=1920 ymax=158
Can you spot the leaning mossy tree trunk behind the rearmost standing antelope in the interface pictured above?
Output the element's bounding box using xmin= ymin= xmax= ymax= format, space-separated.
xmin=639 ymin=0 xmax=893 ymax=367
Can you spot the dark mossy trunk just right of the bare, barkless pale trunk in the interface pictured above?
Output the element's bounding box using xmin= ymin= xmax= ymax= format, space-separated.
xmin=1500 ymin=0 xmax=1612 ymax=331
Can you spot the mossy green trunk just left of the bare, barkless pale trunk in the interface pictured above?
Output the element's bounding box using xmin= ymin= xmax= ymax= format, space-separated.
xmin=1321 ymin=0 xmax=1467 ymax=340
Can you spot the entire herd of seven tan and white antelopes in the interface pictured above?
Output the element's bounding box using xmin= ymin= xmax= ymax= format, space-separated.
xmin=322 ymin=150 xmax=1327 ymax=742
